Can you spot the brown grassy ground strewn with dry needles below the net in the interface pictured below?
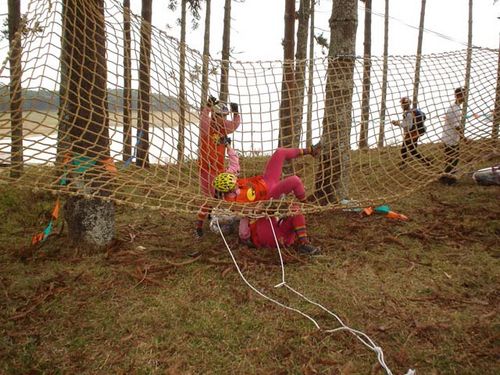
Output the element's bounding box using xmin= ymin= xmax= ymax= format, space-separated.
xmin=0 ymin=172 xmax=500 ymax=375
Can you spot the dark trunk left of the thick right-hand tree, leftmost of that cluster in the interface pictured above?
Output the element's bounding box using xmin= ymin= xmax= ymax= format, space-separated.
xmin=278 ymin=0 xmax=295 ymax=147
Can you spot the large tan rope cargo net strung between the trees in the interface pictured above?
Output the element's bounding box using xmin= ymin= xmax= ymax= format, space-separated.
xmin=0 ymin=0 xmax=498 ymax=219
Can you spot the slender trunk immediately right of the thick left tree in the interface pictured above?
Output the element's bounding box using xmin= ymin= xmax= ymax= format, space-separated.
xmin=123 ymin=0 xmax=132 ymax=161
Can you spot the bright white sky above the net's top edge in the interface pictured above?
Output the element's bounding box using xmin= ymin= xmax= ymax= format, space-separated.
xmin=121 ymin=0 xmax=500 ymax=61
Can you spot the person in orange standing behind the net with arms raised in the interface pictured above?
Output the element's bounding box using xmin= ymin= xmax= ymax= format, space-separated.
xmin=195 ymin=96 xmax=241 ymax=237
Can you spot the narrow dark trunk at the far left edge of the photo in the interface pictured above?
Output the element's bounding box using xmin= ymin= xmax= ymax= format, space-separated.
xmin=9 ymin=0 xmax=23 ymax=178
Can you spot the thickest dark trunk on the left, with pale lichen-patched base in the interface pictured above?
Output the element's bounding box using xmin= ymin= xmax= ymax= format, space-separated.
xmin=63 ymin=0 xmax=114 ymax=252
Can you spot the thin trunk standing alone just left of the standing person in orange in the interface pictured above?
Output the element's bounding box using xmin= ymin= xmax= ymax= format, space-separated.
xmin=177 ymin=0 xmax=187 ymax=164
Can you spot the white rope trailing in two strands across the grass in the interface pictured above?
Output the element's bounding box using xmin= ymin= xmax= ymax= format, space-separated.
xmin=216 ymin=217 xmax=415 ymax=375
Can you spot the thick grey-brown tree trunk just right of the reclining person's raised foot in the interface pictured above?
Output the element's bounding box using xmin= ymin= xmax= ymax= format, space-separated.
xmin=314 ymin=0 xmax=358 ymax=205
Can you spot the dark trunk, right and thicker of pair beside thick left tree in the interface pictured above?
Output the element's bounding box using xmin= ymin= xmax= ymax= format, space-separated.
xmin=136 ymin=0 xmax=153 ymax=168
